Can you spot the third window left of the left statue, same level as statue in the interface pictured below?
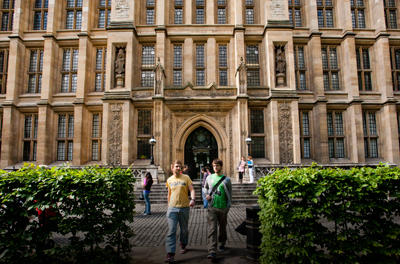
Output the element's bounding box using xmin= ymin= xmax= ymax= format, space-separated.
xmin=28 ymin=49 xmax=43 ymax=93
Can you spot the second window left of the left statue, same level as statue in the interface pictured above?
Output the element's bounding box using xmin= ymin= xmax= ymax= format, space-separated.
xmin=61 ymin=48 xmax=78 ymax=93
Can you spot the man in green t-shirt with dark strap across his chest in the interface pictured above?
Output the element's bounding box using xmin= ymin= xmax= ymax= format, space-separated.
xmin=205 ymin=159 xmax=232 ymax=261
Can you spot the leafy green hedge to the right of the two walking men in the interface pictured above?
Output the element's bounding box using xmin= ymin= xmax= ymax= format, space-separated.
xmin=256 ymin=165 xmax=400 ymax=263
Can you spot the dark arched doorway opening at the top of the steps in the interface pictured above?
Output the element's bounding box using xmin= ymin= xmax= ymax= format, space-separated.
xmin=184 ymin=126 xmax=218 ymax=179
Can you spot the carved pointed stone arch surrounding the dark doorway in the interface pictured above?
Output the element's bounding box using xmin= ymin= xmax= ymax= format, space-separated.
xmin=173 ymin=115 xmax=228 ymax=162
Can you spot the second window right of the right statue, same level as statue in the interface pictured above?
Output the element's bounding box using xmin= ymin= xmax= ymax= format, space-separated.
xmin=321 ymin=46 xmax=340 ymax=91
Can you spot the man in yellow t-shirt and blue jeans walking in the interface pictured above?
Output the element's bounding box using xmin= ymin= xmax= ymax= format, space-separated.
xmin=165 ymin=160 xmax=196 ymax=263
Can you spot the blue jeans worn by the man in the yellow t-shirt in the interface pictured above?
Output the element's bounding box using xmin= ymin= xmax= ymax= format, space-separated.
xmin=165 ymin=207 xmax=189 ymax=253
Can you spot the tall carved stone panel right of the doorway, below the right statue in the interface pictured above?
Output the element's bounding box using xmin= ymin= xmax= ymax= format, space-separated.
xmin=278 ymin=102 xmax=293 ymax=164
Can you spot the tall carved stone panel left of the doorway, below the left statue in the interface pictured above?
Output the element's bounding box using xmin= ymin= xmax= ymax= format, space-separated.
xmin=108 ymin=104 xmax=122 ymax=166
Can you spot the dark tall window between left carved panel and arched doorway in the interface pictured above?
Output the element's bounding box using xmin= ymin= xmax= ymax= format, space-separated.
xmin=136 ymin=108 xmax=153 ymax=159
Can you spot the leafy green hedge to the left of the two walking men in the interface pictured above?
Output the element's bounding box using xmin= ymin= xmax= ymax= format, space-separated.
xmin=0 ymin=165 xmax=135 ymax=263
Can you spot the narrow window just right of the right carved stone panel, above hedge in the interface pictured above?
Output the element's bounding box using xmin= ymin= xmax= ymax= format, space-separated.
xmin=299 ymin=109 xmax=313 ymax=159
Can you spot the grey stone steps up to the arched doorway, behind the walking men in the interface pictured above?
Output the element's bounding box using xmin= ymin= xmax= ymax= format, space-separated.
xmin=135 ymin=181 xmax=257 ymax=205
